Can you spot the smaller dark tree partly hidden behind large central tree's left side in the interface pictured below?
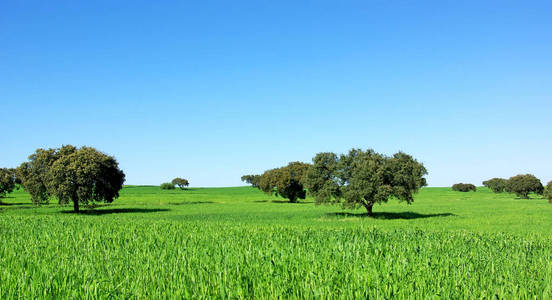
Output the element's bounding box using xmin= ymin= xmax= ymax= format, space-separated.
xmin=257 ymin=162 xmax=309 ymax=203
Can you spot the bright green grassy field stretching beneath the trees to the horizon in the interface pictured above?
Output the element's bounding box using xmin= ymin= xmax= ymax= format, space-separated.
xmin=0 ymin=186 xmax=552 ymax=299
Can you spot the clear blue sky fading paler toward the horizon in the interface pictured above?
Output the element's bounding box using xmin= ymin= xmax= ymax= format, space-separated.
xmin=0 ymin=1 xmax=552 ymax=186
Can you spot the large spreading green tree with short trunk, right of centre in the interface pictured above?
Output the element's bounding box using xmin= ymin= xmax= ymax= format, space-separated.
xmin=305 ymin=149 xmax=427 ymax=216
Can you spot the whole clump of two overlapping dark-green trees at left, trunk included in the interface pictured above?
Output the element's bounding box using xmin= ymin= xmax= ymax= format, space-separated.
xmin=18 ymin=145 xmax=125 ymax=212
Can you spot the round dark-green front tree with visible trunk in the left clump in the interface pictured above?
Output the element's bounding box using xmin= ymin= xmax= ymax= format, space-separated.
xmin=46 ymin=147 xmax=125 ymax=213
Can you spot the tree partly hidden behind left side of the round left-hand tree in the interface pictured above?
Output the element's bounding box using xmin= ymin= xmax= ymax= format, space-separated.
xmin=16 ymin=145 xmax=77 ymax=204
